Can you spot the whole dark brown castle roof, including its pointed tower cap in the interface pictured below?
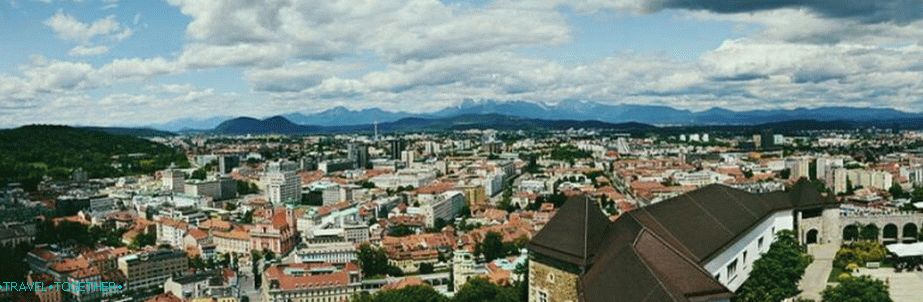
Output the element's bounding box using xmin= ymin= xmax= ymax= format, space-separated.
xmin=529 ymin=181 xmax=832 ymax=301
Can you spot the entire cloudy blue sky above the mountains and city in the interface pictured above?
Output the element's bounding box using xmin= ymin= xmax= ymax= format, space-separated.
xmin=0 ymin=0 xmax=923 ymax=127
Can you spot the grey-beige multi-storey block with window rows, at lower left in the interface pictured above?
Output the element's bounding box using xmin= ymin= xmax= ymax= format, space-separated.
xmin=119 ymin=249 xmax=189 ymax=291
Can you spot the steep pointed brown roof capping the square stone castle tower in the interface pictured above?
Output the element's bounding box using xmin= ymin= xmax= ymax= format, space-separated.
xmin=529 ymin=196 xmax=609 ymax=267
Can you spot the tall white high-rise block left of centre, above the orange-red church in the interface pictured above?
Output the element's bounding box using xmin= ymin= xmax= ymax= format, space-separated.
xmin=262 ymin=161 xmax=301 ymax=205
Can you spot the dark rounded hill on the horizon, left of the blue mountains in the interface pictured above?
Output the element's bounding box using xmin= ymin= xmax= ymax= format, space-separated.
xmin=211 ymin=116 xmax=322 ymax=135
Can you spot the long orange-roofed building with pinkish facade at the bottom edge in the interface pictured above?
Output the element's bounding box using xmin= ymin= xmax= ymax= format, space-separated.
xmin=262 ymin=263 xmax=362 ymax=302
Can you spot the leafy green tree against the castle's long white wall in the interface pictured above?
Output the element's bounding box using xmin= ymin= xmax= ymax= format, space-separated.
xmin=737 ymin=230 xmax=812 ymax=302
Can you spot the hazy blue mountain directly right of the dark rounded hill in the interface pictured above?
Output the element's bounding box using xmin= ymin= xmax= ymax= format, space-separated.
xmin=282 ymin=106 xmax=419 ymax=126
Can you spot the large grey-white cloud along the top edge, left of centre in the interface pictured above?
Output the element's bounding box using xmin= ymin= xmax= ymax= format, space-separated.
xmin=169 ymin=0 xmax=569 ymax=65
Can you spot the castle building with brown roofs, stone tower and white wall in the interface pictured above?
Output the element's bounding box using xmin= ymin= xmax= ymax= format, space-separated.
xmin=528 ymin=181 xmax=837 ymax=302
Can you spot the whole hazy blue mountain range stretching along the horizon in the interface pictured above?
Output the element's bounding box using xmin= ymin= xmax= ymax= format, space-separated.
xmin=155 ymin=100 xmax=923 ymax=131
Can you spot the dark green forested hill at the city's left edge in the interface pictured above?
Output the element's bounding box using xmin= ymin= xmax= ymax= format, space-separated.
xmin=0 ymin=125 xmax=189 ymax=190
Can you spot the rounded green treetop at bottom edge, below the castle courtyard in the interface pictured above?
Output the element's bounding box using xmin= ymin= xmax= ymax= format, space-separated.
xmin=821 ymin=276 xmax=891 ymax=302
